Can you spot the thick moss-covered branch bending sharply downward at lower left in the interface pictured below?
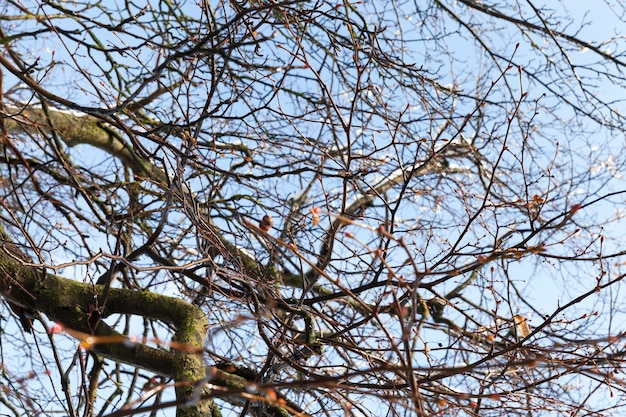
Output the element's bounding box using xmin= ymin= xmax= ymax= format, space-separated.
xmin=0 ymin=233 xmax=219 ymax=417
